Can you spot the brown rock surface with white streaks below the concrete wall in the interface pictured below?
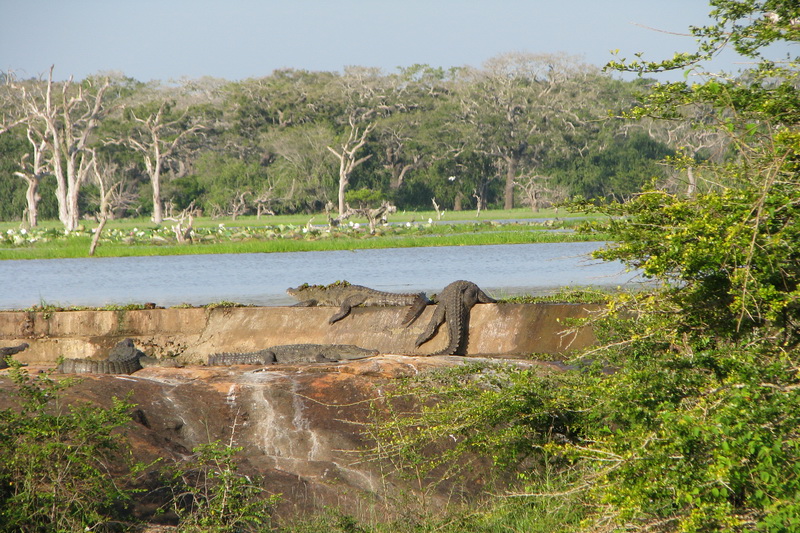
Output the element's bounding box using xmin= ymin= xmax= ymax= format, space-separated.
xmin=0 ymin=355 xmax=559 ymax=515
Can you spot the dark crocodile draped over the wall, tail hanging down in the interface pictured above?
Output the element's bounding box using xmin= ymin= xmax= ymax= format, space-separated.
xmin=415 ymin=280 xmax=497 ymax=355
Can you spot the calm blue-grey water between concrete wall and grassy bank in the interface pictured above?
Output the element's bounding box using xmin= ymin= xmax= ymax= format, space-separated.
xmin=0 ymin=242 xmax=641 ymax=309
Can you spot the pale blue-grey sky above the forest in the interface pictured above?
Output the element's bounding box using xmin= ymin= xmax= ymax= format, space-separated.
xmin=0 ymin=0 xmax=780 ymax=82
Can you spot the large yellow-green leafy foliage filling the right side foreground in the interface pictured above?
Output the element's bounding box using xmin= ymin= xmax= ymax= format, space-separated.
xmin=364 ymin=0 xmax=800 ymax=532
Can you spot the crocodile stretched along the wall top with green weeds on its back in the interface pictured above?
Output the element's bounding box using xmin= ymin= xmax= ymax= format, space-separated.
xmin=286 ymin=281 xmax=431 ymax=326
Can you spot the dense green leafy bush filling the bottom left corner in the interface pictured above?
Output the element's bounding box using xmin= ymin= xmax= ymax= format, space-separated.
xmin=0 ymin=361 xmax=132 ymax=532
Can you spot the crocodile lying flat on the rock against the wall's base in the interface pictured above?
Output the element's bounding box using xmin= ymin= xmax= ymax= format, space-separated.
xmin=208 ymin=344 xmax=378 ymax=366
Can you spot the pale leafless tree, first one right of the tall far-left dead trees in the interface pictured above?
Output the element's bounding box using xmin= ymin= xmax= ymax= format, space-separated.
xmin=126 ymin=102 xmax=202 ymax=224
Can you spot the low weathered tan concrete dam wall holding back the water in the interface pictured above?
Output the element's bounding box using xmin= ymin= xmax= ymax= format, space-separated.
xmin=0 ymin=304 xmax=597 ymax=363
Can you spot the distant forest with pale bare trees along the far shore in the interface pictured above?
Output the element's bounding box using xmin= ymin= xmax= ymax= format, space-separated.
xmin=0 ymin=54 xmax=728 ymax=229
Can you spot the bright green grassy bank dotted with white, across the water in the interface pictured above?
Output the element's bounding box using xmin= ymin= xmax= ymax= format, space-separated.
xmin=0 ymin=210 xmax=603 ymax=259
